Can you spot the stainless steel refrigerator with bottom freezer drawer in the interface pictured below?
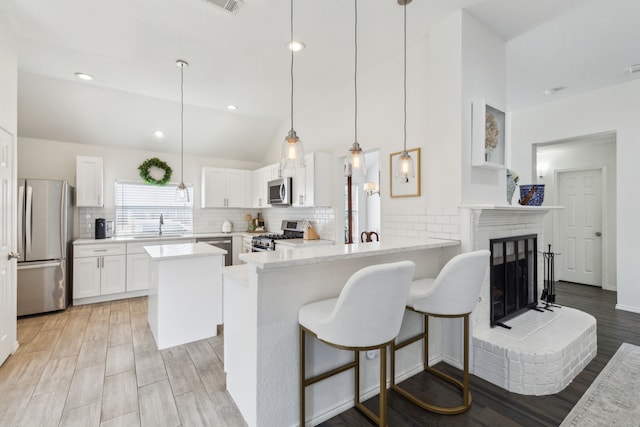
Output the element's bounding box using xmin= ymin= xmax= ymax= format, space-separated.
xmin=17 ymin=179 xmax=73 ymax=316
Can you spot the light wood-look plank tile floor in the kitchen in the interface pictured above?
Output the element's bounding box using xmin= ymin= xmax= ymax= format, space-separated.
xmin=0 ymin=298 xmax=246 ymax=427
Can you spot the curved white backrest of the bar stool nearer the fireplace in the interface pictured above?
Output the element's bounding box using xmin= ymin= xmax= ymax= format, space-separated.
xmin=411 ymin=249 xmax=491 ymax=315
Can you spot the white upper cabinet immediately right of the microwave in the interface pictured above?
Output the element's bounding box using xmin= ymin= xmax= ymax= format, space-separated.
xmin=292 ymin=153 xmax=333 ymax=207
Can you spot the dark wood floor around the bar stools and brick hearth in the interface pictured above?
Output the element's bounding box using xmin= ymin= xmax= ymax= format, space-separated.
xmin=321 ymin=282 xmax=640 ymax=427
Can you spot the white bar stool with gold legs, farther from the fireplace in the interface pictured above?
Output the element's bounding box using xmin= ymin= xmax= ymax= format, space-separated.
xmin=298 ymin=261 xmax=415 ymax=426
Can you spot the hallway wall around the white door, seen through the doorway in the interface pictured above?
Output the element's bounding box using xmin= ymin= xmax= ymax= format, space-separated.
xmin=537 ymin=140 xmax=617 ymax=291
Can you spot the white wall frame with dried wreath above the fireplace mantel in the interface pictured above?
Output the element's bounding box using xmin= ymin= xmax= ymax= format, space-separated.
xmin=471 ymin=100 xmax=509 ymax=169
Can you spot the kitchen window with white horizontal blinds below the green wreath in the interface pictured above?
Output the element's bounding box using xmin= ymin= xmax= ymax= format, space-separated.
xmin=115 ymin=181 xmax=193 ymax=236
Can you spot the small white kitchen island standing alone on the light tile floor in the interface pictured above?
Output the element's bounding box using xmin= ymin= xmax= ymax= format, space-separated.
xmin=144 ymin=243 xmax=227 ymax=350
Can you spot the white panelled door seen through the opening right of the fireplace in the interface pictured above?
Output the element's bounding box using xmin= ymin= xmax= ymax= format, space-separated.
xmin=556 ymin=169 xmax=602 ymax=286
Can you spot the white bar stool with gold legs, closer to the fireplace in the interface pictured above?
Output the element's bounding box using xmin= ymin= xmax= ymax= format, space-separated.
xmin=391 ymin=250 xmax=491 ymax=415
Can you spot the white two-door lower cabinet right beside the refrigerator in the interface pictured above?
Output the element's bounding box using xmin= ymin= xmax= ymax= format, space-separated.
xmin=73 ymin=243 xmax=127 ymax=300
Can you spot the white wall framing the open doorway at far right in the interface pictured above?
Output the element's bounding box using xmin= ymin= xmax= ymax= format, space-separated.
xmin=512 ymin=80 xmax=640 ymax=312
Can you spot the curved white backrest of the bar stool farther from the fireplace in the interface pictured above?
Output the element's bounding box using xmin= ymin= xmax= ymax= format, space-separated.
xmin=315 ymin=261 xmax=415 ymax=347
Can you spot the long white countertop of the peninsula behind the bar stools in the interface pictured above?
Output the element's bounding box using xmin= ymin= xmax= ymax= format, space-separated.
xmin=240 ymin=238 xmax=460 ymax=269
